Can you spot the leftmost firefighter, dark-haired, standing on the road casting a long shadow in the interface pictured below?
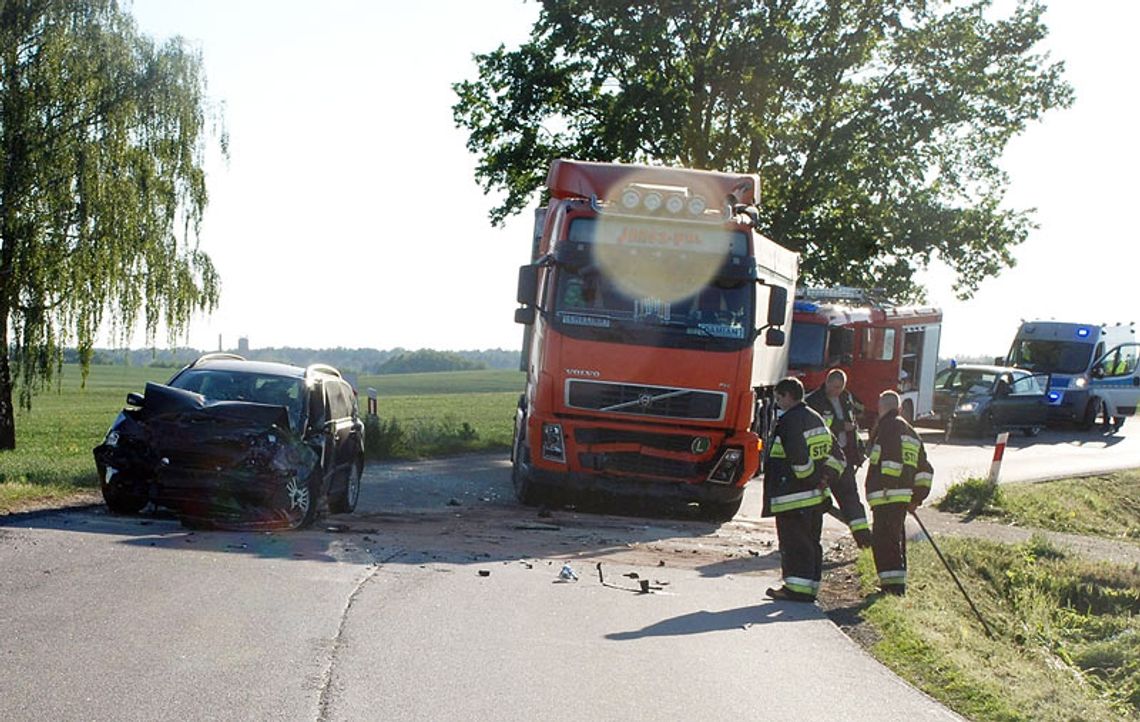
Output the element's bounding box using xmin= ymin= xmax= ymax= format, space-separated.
xmin=764 ymin=379 xmax=834 ymax=602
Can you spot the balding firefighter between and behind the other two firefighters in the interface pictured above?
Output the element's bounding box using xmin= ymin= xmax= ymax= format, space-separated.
xmin=804 ymin=368 xmax=871 ymax=549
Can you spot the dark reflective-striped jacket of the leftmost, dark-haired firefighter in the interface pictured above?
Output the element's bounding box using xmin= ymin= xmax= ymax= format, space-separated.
xmin=764 ymin=403 xmax=844 ymax=517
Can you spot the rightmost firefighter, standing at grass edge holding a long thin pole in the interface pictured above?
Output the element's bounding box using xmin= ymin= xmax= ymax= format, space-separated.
xmin=866 ymin=391 xmax=934 ymax=595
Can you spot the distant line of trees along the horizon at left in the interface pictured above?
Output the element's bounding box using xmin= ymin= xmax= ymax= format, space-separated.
xmin=64 ymin=347 xmax=519 ymax=374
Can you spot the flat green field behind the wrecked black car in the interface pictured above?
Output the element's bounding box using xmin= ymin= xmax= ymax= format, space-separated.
xmin=0 ymin=366 xmax=524 ymax=511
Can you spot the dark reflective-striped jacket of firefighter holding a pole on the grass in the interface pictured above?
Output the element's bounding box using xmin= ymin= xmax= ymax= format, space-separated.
xmin=866 ymin=411 xmax=934 ymax=509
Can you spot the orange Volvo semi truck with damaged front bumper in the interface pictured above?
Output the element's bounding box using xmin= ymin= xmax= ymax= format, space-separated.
xmin=512 ymin=160 xmax=799 ymax=519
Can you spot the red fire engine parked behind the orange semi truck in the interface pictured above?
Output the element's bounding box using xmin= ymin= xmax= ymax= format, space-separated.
xmin=788 ymin=286 xmax=942 ymax=428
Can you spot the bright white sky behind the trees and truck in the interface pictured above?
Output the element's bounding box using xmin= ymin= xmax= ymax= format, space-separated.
xmin=124 ymin=0 xmax=1140 ymax=356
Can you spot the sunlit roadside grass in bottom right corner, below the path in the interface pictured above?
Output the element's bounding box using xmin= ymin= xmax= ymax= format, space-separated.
xmin=858 ymin=538 xmax=1140 ymax=722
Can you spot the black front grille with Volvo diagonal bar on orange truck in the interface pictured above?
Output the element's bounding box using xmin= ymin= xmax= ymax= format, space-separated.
xmin=567 ymin=379 xmax=727 ymax=421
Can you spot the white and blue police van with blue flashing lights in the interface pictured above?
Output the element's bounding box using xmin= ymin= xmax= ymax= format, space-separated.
xmin=1008 ymin=321 xmax=1140 ymax=430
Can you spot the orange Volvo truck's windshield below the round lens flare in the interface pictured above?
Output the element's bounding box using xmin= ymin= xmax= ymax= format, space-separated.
xmin=554 ymin=266 xmax=755 ymax=348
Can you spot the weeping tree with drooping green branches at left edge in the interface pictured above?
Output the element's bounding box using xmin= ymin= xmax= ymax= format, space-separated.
xmin=0 ymin=0 xmax=226 ymax=449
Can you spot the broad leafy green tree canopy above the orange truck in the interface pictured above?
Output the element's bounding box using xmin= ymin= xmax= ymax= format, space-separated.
xmin=453 ymin=0 xmax=1072 ymax=298
